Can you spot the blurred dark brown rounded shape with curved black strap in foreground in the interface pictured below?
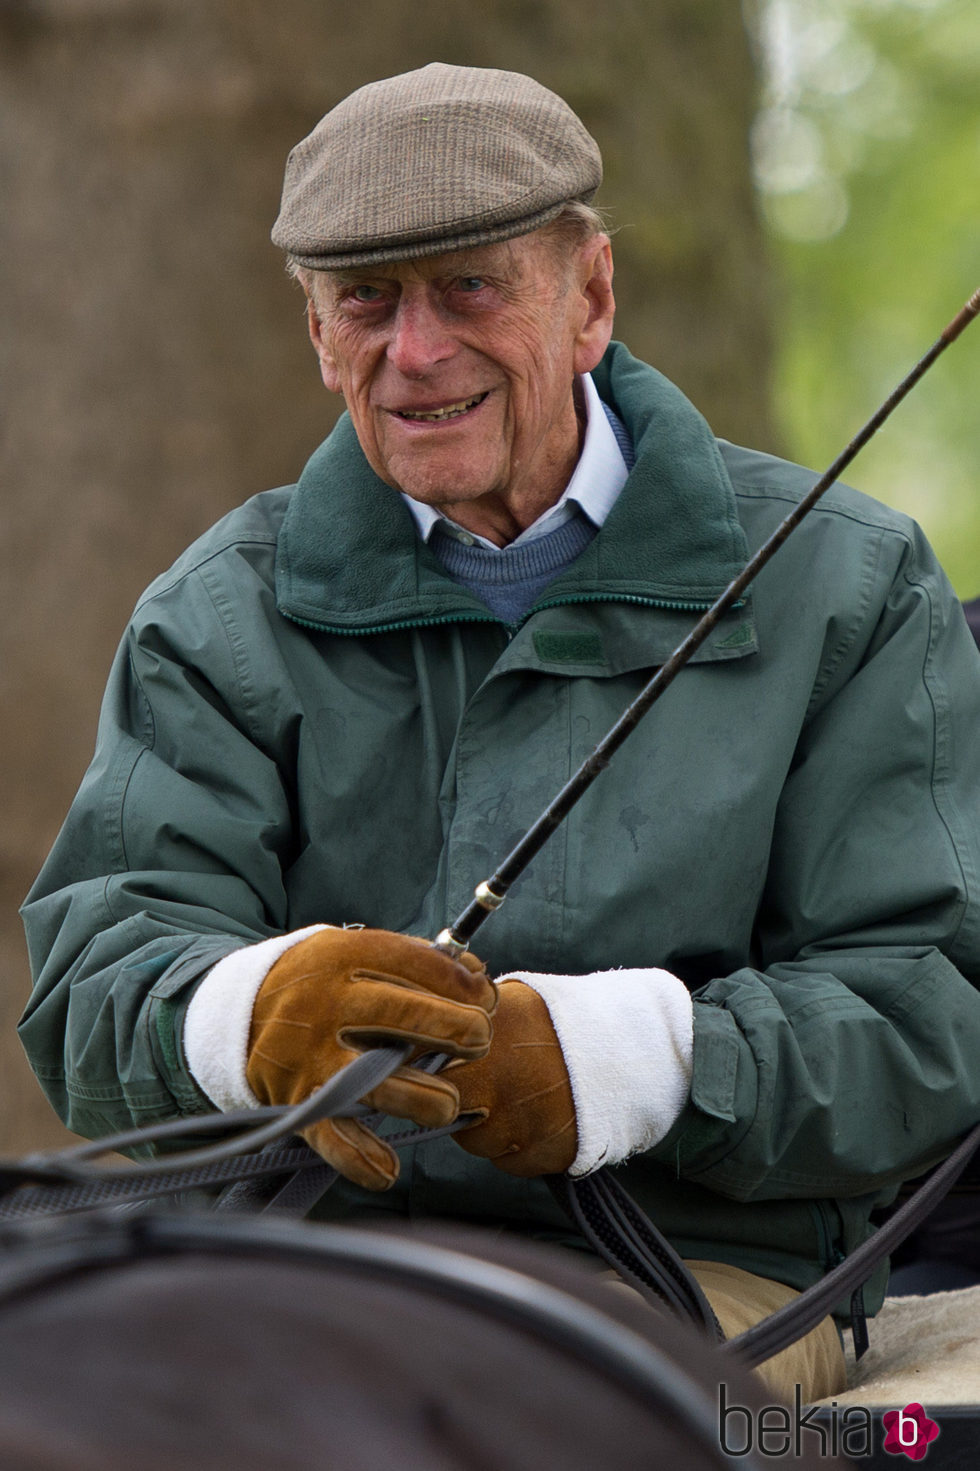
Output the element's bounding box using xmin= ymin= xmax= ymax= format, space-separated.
xmin=0 ymin=1211 xmax=842 ymax=1471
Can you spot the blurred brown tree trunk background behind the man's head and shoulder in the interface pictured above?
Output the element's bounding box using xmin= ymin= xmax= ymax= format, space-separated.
xmin=0 ymin=0 xmax=773 ymax=1152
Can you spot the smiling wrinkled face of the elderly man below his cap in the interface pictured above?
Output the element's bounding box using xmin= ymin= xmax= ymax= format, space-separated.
xmin=310 ymin=231 xmax=612 ymax=534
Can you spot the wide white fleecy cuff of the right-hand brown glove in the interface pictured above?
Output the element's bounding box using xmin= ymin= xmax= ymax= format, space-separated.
xmin=502 ymin=968 xmax=695 ymax=1175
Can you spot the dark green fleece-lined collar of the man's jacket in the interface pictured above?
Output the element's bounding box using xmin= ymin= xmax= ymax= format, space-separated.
xmin=275 ymin=343 xmax=748 ymax=634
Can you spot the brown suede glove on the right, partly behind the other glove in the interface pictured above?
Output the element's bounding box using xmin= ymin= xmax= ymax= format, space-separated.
xmin=443 ymin=980 xmax=578 ymax=1177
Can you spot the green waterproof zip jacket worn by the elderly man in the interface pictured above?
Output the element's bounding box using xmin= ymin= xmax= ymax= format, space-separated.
xmin=21 ymin=344 xmax=980 ymax=1312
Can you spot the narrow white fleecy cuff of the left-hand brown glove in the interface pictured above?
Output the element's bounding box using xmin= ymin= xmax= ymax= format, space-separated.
xmin=184 ymin=924 xmax=331 ymax=1114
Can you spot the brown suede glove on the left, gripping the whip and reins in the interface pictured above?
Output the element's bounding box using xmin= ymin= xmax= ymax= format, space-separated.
xmin=246 ymin=930 xmax=496 ymax=1190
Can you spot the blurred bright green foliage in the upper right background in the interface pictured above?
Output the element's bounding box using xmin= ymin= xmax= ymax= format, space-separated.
xmin=753 ymin=0 xmax=980 ymax=597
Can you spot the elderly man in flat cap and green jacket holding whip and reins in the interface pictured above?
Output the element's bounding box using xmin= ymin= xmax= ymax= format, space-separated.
xmin=22 ymin=65 xmax=980 ymax=1397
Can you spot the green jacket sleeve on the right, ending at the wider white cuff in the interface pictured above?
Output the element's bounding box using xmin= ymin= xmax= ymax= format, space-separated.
xmin=655 ymin=529 xmax=980 ymax=1200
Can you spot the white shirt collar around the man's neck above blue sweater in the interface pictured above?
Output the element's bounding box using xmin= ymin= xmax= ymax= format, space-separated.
xmin=399 ymin=374 xmax=630 ymax=552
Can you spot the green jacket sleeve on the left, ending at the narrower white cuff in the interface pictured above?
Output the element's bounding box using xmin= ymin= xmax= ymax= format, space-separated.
xmin=21 ymin=574 xmax=291 ymax=1137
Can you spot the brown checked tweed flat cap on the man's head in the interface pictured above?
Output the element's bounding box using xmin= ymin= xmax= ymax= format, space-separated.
xmin=272 ymin=62 xmax=602 ymax=271
